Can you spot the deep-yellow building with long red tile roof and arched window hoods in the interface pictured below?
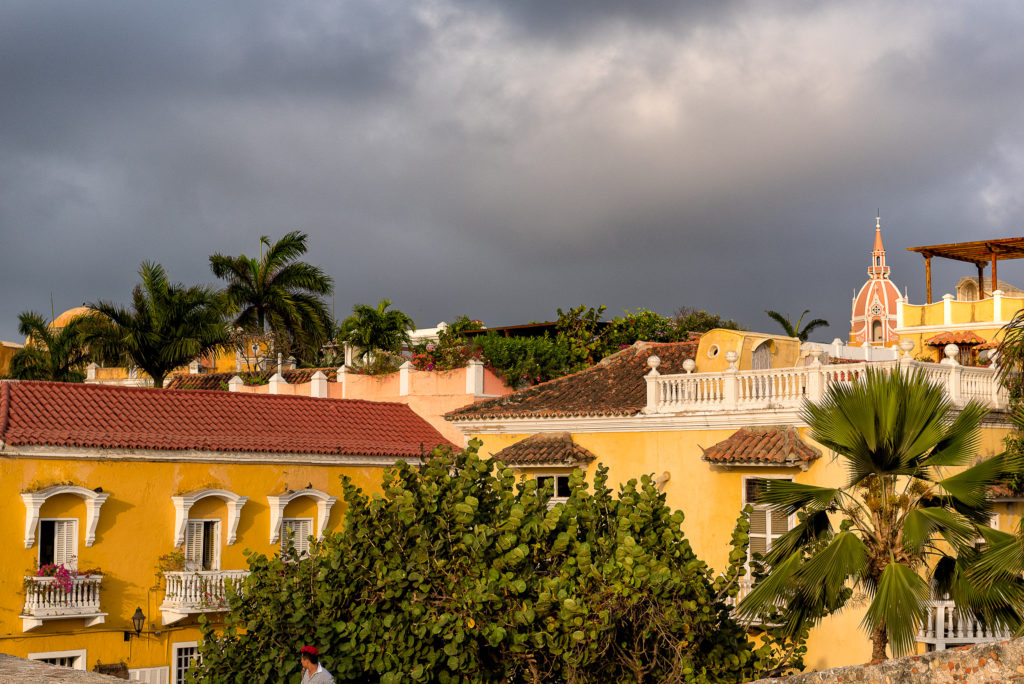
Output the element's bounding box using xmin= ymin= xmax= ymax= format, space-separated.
xmin=0 ymin=382 xmax=450 ymax=682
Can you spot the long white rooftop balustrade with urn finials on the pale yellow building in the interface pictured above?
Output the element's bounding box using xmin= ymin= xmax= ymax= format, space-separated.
xmin=645 ymin=352 xmax=1010 ymax=414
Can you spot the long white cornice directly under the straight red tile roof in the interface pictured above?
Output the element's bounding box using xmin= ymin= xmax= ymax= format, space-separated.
xmin=0 ymin=442 xmax=420 ymax=468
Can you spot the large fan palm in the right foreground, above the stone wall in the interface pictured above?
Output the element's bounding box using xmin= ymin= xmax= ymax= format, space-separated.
xmin=738 ymin=369 xmax=1024 ymax=659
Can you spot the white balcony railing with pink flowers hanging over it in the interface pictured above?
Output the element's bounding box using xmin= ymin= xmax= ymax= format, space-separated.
xmin=19 ymin=574 xmax=106 ymax=632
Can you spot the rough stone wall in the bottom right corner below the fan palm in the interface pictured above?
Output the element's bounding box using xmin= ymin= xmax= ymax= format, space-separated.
xmin=754 ymin=639 xmax=1024 ymax=684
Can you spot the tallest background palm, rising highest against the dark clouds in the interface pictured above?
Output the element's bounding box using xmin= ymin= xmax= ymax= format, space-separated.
xmin=210 ymin=230 xmax=334 ymax=358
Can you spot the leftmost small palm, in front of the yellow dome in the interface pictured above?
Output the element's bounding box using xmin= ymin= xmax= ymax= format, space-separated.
xmin=10 ymin=311 xmax=89 ymax=382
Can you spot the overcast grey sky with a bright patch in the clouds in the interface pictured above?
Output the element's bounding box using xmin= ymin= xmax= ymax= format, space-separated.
xmin=0 ymin=0 xmax=1024 ymax=341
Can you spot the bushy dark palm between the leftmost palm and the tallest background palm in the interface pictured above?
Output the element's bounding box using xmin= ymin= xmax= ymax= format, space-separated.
xmin=83 ymin=261 xmax=227 ymax=387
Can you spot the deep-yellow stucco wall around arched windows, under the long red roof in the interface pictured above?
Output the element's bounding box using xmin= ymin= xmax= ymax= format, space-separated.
xmin=0 ymin=457 xmax=382 ymax=670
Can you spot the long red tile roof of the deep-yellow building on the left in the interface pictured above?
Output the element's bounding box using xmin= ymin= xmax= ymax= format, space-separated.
xmin=0 ymin=381 xmax=454 ymax=458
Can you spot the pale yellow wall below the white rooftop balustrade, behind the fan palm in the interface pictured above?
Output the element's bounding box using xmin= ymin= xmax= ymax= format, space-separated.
xmin=470 ymin=425 xmax=1009 ymax=670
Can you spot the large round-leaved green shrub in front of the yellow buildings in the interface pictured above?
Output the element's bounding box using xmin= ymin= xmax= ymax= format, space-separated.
xmin=193 ymin=444 xmax=790 ymax=683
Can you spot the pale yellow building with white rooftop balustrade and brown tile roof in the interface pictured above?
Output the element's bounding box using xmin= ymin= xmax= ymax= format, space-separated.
xmin=447 ymin=333 xmax=1017 ymax=669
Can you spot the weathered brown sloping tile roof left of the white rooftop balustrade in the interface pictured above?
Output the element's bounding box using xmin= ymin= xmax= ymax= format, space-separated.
xmin=444 ymin=336 xmax=699 ymax=421
